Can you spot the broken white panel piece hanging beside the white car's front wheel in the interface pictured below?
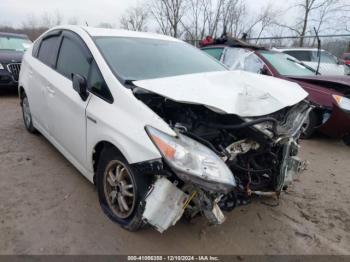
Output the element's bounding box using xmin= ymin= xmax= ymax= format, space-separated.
xmin=143 ymin=177 xmax=188 ymax=233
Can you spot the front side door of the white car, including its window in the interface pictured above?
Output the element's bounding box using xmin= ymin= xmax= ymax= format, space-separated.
xmin=48 ymin=32 xmax=92 ymax=170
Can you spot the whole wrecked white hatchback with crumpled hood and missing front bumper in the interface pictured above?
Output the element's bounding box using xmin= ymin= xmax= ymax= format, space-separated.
xmin=19 ymin=26 xmax=311 ymax=232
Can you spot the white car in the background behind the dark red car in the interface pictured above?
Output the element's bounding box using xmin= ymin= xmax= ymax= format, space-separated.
xmin=275 ymin=48 xmax=350 ymax=75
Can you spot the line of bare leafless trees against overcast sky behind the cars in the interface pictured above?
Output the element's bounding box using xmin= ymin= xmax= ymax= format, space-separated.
xmin=0 ymin=0 xmax=350 ymax=46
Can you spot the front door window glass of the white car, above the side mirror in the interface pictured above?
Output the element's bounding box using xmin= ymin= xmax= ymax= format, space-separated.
xmin=56 ymin=37 xmax=90 ymax=79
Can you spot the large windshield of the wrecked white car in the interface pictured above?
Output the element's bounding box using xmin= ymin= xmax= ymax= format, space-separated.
xmin=95 ymin=37 xmax=227 ymax=80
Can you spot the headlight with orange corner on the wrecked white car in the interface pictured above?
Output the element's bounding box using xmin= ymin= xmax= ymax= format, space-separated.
xmin=146 ymin=126 xmax=236 ymax=192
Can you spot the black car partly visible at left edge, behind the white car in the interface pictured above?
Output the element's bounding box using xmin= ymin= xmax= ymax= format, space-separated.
xmin=0 ymin=32 xmax=32 ymax=88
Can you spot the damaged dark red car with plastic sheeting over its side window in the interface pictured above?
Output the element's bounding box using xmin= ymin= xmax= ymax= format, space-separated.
xmin=202 ymin=40 xmax=350 ymax=145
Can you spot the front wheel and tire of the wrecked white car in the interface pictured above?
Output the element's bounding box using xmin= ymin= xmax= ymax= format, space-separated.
xmin=96 ymin=147 xmax=152 ymax=231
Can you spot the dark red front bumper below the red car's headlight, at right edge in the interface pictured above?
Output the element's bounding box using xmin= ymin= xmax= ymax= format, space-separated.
xmin=318 ymin=104 xmax=350 ymax=138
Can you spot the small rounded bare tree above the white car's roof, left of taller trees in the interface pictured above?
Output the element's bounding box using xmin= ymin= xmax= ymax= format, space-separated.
xmin=120 ymin=6 xmax=148 ymax=31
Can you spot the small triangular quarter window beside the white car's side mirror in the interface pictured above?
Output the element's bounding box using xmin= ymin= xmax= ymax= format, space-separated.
xmin=88 ymin=62 xmax=113 ymax=102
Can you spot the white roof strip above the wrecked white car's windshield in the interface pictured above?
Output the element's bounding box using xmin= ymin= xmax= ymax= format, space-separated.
xmin=50 ymin=25 xmax=182 ymax=42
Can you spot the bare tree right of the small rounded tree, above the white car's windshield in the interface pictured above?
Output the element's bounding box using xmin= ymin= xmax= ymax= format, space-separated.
xmin=150 ymin=0 xmax=186 ymax=37
